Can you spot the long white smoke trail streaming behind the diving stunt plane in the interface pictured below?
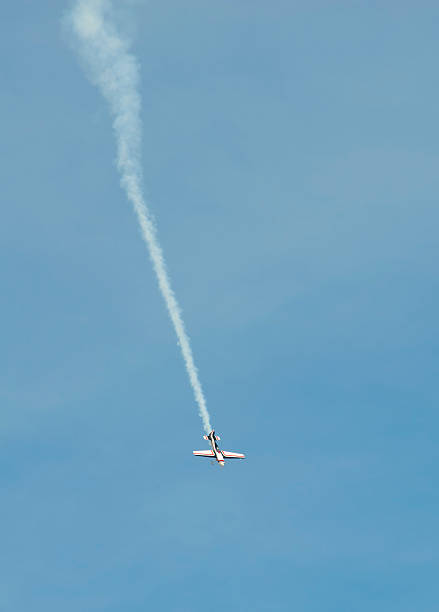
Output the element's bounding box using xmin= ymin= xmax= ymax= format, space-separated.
xmin=68 ymin=0 xmax=212 ymax=433
